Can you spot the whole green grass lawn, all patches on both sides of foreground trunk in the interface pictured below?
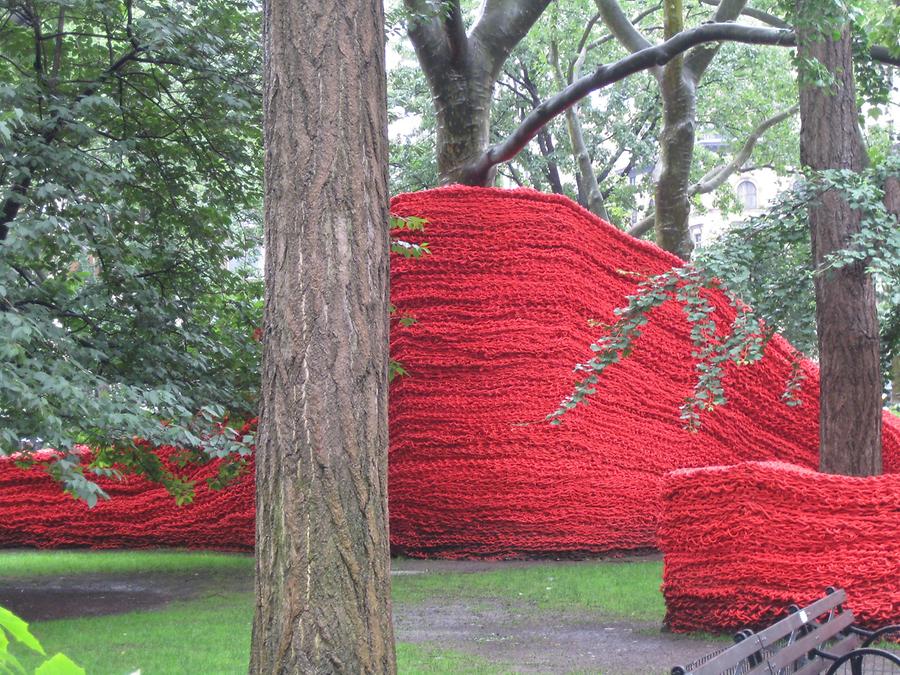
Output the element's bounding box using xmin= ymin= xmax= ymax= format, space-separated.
xmin=0 ymin=551 xmax=664 ymax=675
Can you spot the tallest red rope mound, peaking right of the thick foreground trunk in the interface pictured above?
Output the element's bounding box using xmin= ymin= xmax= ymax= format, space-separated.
xmin=388 ymin=187 xmax=900 ymax=560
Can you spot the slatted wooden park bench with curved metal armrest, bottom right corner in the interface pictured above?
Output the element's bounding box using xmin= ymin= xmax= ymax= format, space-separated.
xmin=672 ymin=588 xmax=900 ymax=675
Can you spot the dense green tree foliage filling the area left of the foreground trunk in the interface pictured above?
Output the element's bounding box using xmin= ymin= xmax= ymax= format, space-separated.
xmin=0 ymin=0 xmax=262 ymax=499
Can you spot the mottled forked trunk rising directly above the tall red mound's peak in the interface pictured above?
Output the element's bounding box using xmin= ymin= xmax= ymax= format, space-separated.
xmin=404 ymin=0 xmax=551 ymax=184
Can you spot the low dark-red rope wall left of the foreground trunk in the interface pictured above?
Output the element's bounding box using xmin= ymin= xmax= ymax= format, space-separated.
xmin=0 ymin=447 xmax=255 ymax=551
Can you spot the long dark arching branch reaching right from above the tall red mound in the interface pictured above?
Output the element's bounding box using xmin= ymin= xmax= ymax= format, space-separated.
xmin=466 ymin=23 xmax=796 ymax=185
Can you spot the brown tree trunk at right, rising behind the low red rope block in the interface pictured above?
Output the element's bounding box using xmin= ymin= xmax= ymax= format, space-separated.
xmin=797 ymin=6 xmax=882 ymax=476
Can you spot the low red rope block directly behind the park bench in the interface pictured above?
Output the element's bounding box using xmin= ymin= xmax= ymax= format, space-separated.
xmin=659 ymin=462 xmax=900 ymax=632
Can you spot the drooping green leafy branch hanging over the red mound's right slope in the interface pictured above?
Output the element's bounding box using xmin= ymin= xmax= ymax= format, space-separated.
xmin=547 ymin=158 xmax=900 ymax=431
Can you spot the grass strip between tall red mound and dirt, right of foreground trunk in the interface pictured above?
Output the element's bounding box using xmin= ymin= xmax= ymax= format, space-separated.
xmin=392 ymin=560 xmax=666 ymax=621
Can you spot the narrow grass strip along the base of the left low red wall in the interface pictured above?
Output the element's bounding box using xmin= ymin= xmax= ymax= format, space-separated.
xmin=0 ymin=550 xmax=254 ymax=578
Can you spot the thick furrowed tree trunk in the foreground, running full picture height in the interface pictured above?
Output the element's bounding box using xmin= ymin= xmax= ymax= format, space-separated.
xmin=250 ymin=0 xmax=395 ymax=675
